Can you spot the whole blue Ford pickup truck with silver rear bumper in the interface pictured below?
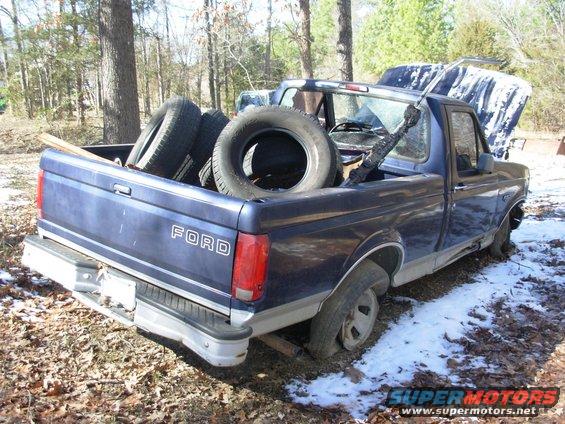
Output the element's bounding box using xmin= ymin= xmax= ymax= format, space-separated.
xmin=23 ymin=80 xmax=529 ymax=366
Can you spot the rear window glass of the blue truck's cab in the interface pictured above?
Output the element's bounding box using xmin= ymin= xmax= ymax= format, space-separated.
xmin=280 ymin=88 xmax=429 ymax=162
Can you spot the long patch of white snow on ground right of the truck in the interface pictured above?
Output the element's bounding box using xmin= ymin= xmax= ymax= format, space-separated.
xmin=286 ymin=155 xmax=565 ymax=419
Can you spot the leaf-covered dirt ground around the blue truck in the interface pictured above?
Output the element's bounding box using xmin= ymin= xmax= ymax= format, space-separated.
xmin=0 ymin=116 xmax=565 ymax=423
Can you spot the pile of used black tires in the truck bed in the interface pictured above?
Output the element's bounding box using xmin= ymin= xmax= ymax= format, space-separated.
xmin=126 ymin=97 xmax=343 ymax=199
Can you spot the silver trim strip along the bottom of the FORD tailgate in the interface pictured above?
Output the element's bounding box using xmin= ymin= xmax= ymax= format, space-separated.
xmin=38 ymin=227 xmax=230 ymax=316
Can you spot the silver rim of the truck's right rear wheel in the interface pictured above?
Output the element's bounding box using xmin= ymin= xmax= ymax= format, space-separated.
xmin=339 ymin=289 xmax=379 ymax=350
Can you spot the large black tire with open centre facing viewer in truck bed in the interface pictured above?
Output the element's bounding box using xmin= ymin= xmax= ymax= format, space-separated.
xmin=212 ymin=106 xmax=337 ymax=199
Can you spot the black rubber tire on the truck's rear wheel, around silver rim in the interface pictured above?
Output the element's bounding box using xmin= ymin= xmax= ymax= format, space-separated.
xmin=308 ymin=260 xmax=390 ymax=359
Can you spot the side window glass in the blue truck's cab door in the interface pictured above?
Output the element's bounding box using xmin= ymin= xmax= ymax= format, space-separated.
xmin=451 ymin=112 xmax=478 ymax=174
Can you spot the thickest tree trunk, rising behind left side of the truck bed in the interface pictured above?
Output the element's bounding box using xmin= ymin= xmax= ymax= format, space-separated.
xmin=99 ymin=0 xmax=140 ymax=143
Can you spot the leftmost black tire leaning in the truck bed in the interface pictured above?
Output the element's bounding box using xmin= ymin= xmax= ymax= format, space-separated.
xmin=126 ymin=97 xmax=200 ymax=178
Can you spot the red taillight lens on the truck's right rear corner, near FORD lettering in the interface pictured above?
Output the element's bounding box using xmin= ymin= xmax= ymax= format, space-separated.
xmin=231 ymin=233 xmax=270 ymax=302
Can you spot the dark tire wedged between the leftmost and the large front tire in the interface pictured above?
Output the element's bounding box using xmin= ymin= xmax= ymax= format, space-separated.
xmin=173 ymin=109 xmax=230 ymax=185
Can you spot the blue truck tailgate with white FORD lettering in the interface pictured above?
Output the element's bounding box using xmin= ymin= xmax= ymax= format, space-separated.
xmin=38 ymin=150 xmax=244 ymax=313
